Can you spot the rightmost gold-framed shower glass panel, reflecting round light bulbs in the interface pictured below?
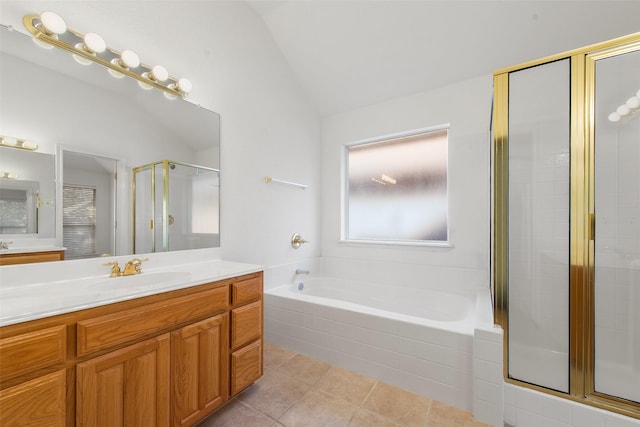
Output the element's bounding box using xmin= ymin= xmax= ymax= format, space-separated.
xmin=593 ymin=50 xmax=640 ymax=402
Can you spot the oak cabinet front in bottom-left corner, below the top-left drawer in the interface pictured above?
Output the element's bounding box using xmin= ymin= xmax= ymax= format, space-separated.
xmin=0 ymin=369 xmax=67 ymax=427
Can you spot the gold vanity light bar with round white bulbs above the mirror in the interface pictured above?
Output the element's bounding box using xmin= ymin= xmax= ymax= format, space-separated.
xmin=22 ymin=11 xmax=193 ymax=99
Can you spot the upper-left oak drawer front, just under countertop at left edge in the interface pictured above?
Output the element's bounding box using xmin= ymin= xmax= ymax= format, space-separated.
xmin=0 ymin=325 xmax=67 ymax=378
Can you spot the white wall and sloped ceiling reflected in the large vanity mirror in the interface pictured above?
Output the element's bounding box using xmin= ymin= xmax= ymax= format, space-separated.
xmin=0 ymin=26 xmax=220 ymax=255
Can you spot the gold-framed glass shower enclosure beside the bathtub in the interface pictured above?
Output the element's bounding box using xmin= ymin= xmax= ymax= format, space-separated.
xmin=492 ymin=33 xmax=640 ymax=418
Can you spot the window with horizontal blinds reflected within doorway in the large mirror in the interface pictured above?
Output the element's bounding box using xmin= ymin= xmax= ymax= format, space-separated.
xmin=62 ymin=185 xmax=96 ymax=259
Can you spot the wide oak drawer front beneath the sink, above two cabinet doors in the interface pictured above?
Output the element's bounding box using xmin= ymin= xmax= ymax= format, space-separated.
xmin=78 ymin=286 xmax=229 ymax=356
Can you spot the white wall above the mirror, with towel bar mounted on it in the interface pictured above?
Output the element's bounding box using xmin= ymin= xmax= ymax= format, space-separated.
xmin=0 ymin=1 xmax=320 ymax=265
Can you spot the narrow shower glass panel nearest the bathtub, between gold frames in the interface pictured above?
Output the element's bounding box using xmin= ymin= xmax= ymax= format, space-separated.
xmin=508 ymin=60 xmax=570 ymax=392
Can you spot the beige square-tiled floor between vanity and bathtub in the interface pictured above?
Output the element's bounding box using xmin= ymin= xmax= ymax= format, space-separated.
xmin=198 ymin=343 xmax=488 ymax=427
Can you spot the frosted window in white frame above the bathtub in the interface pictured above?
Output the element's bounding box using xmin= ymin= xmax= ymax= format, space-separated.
xmin=343 ymin=127 xmax=449 ymax=245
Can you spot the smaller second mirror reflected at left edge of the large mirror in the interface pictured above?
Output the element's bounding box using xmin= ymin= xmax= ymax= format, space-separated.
xmin=0 ymin=147 xmax=55 ymax=239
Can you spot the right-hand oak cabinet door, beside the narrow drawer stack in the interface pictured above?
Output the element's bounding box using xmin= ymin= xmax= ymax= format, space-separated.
xmin=171 ymin=313 xmax=229 ymax=426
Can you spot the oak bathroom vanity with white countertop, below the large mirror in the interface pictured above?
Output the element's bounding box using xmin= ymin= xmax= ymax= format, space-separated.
xmin=0 ymin=261 xmax=263 ymax=426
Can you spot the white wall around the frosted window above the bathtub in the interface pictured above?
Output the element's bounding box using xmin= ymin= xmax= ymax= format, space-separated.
xmin=321 ymin=76 xmax=493 ymax=290
